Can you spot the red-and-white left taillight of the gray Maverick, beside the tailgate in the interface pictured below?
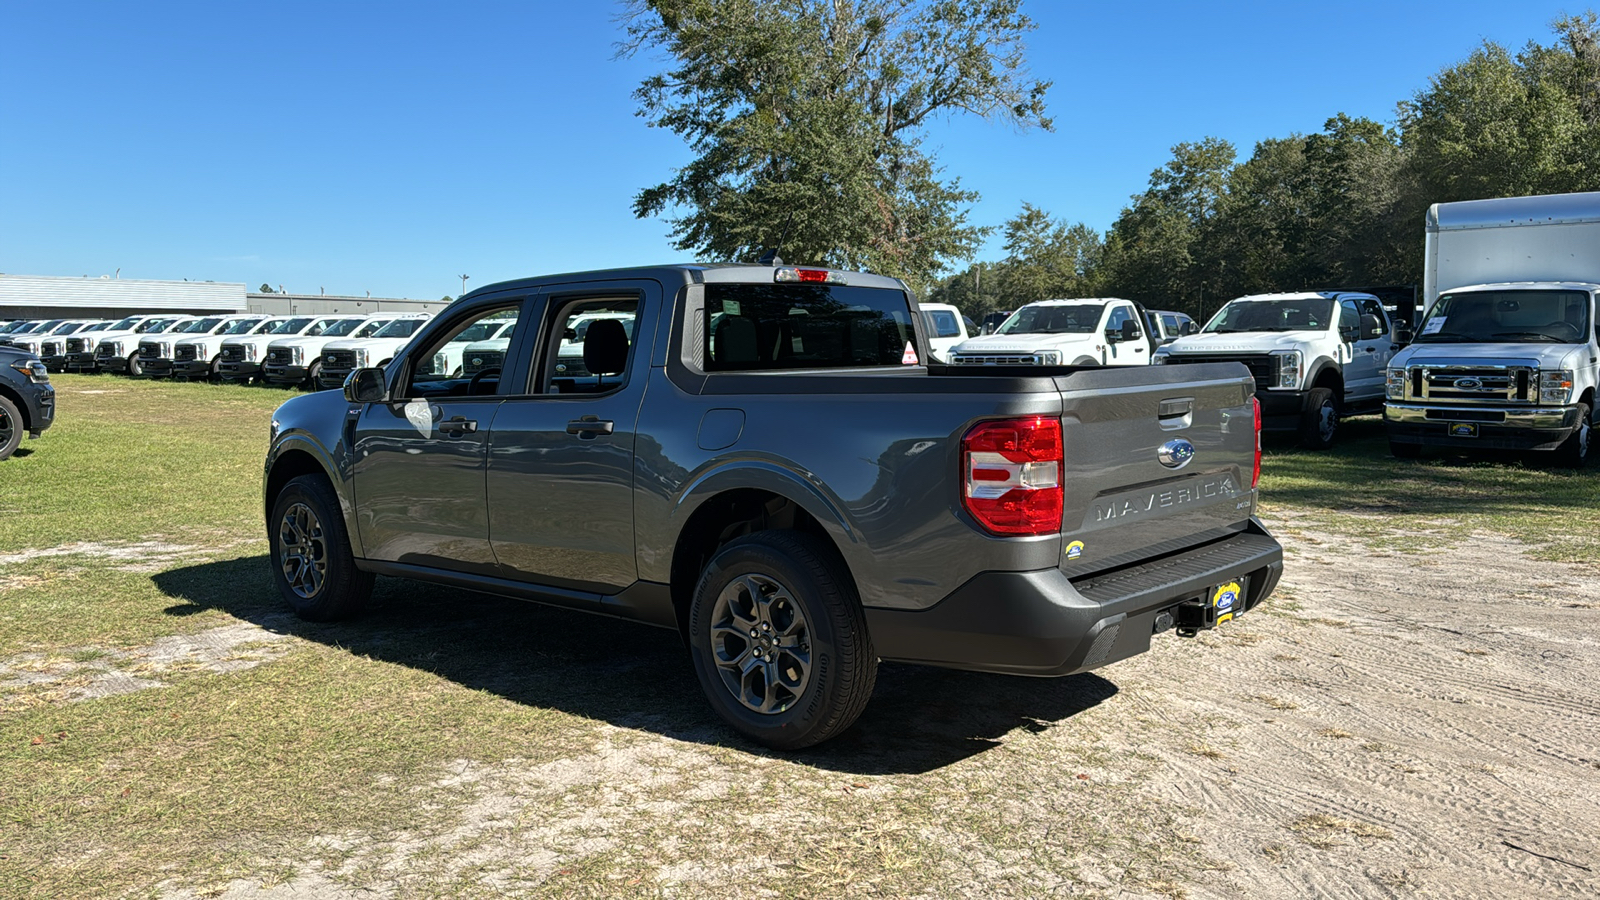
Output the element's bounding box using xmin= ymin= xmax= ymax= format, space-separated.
xmin=962 ymin=416 xmax=1064 ymax=535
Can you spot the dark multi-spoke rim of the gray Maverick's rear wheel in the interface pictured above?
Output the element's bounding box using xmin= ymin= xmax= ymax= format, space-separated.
xmin=710 ymin=573 xmax=811 ymax=716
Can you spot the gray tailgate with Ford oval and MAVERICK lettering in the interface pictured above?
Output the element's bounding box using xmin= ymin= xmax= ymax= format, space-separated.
xmin=1056 ymin=364 xmax=1256 ymax=578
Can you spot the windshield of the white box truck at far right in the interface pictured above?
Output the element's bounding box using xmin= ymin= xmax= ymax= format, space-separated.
xmin=1416 ymin=290 xmax=1589 ymax=344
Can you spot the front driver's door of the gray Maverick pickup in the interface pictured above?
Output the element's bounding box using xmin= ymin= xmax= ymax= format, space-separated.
xmin=352 ymin=298 xmax=525 ymax=575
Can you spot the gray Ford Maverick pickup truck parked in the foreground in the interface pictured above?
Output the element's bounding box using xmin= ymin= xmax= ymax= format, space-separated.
xmin=264 ymin=266 xmax=1283 ymax=749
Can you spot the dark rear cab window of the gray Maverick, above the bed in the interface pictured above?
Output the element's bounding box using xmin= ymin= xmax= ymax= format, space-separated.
xmin=704 ymin=283 xmax=917 ymax=372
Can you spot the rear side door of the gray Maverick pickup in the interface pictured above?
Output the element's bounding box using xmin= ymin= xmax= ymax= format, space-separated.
xmin=488 ymin=282 xmax=661 ymax=594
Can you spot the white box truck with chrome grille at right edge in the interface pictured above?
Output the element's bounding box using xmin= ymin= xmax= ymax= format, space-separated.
xmin=1384 ymin=194 xmax=1600 ymax=468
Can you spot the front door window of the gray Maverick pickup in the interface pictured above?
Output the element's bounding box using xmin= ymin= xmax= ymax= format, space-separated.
xmin=405 ymin=299 xmax=522 ymax=397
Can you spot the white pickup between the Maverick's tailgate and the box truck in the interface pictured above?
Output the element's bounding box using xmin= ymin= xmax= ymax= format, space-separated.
xmin=1154 ymin=291 xmax=1400 ymax=450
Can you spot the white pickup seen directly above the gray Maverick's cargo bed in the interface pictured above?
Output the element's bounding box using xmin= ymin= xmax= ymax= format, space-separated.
xmin=950 ymin=296 xmax=1155 ymax=365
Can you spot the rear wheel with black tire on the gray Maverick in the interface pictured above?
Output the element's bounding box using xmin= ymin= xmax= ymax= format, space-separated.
xmin=690 ymin=532 xmax=878 ymax=749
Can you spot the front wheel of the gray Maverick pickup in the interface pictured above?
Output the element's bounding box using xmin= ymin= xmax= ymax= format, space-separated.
xmin=267 ymin=476 xmax=373 ymax=621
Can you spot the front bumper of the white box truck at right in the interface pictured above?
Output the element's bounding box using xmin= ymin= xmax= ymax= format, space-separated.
xmin=1384 ymin=404 xmax=1578 ymax=450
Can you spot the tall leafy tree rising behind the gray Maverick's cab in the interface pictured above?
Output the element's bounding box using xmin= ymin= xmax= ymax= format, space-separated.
xmin=621 ymin=0 xmax=1051 ymax=285
